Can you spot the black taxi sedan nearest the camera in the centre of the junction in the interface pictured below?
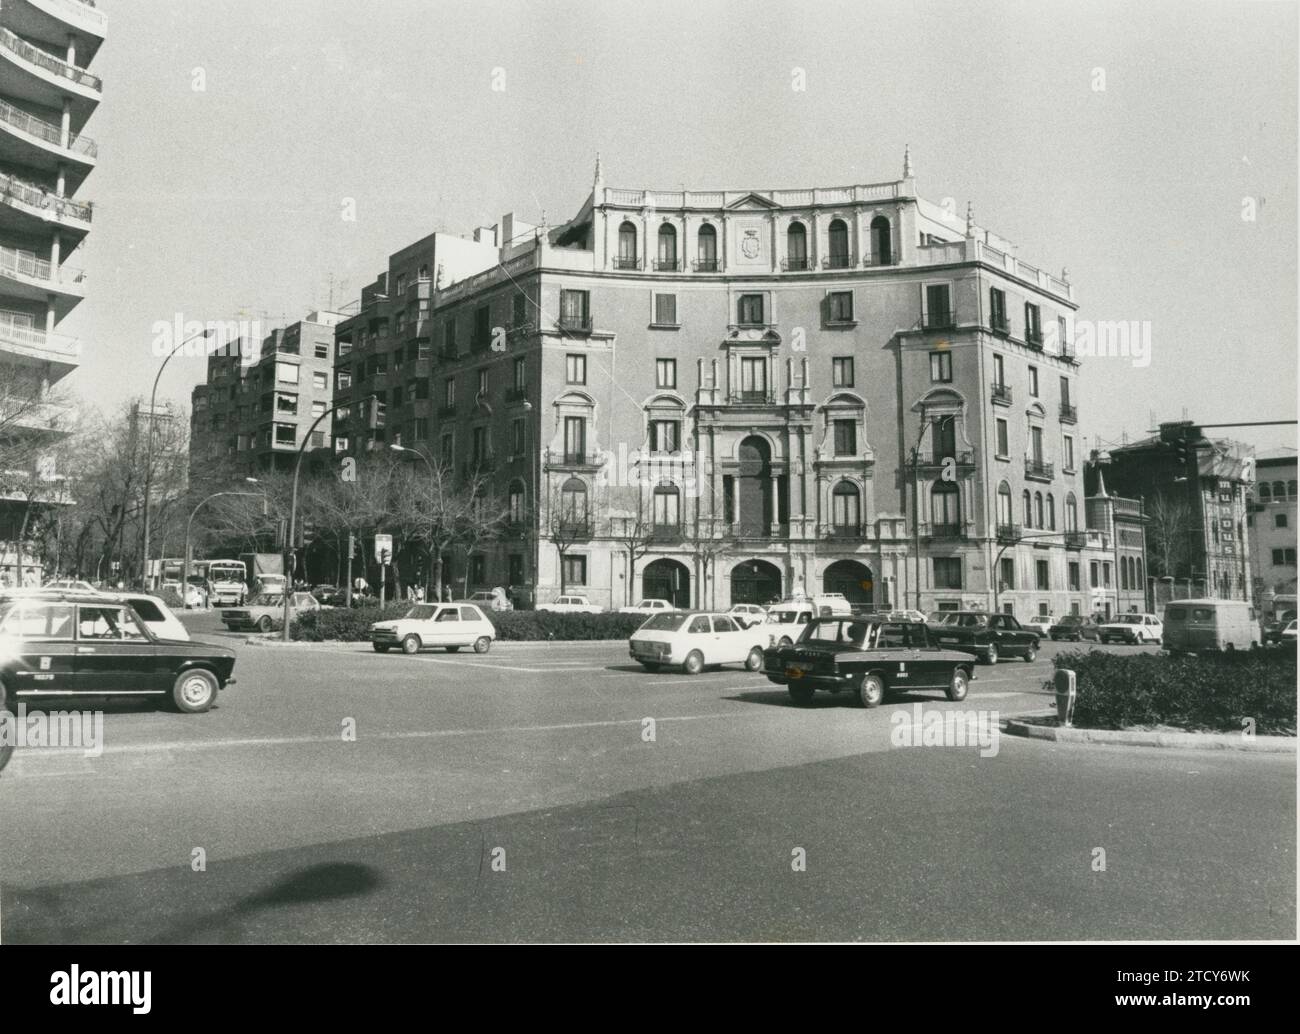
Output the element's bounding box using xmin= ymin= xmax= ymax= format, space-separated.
xmin=763 ymin=615 xmax=975 ymax=708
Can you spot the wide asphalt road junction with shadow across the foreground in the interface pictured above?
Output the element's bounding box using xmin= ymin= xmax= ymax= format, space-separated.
xmin=0 ymin=621 xmax=1296 ymax=943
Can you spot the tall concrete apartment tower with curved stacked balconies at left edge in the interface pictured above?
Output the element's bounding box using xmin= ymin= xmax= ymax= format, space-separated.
xmin=0 ymin=0 xmax=107 ymax=580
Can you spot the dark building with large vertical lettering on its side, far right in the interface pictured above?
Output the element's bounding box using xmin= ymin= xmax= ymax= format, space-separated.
xmin=1097 ymin=420 xmax=1253 ymax=607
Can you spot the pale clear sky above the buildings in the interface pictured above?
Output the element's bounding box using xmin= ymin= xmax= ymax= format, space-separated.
xmin=60 ymin=0 xmax=1297 ymax=447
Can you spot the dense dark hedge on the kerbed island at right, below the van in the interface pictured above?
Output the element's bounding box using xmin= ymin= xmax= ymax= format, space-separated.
xmin=1044 ymin=648 xmax=1296 ymax=736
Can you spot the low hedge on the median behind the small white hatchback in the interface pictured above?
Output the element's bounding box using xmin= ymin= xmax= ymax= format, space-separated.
xmin=289 ymin=602 xmax=646 ymax=643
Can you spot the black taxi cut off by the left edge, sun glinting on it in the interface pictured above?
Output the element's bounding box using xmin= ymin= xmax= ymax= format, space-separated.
xmin=0 ymin=593 xmax=235 ymax=714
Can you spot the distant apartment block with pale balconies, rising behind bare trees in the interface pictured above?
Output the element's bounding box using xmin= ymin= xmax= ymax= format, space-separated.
xmin=190 ymin=311 xmax=346 ymax=473
